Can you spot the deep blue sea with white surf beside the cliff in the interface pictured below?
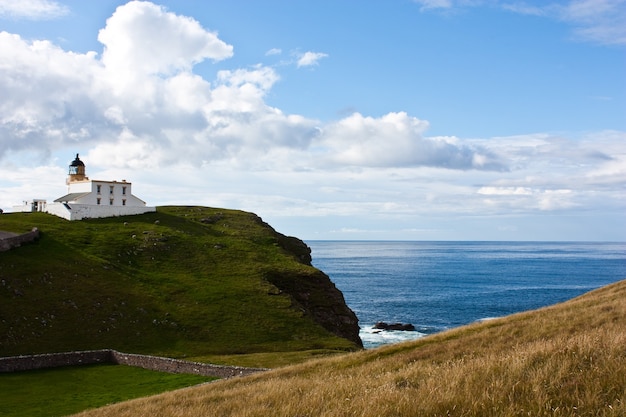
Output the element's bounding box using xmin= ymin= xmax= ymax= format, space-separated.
xmin=306 ymin=241 xmax=626 ymax=348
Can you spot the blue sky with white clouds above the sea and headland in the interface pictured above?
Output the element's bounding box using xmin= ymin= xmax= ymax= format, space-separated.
xmin=0 ymin=0 xmax=626 ymax=241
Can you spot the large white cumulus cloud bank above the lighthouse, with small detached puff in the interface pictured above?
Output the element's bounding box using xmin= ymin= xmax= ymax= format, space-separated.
xmin=0 ymin=1 xmax=505 ymax=170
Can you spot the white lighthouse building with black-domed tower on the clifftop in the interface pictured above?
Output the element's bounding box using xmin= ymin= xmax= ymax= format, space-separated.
xmin=15 ymin=154 xmax=156 ymax=220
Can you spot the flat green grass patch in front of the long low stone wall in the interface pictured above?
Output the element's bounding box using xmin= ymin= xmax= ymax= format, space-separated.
xmin=0 ymin=365 xmax=215 ymax=417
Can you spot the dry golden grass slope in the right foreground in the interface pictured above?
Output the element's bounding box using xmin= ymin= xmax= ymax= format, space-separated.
xmin=70 ymin=282 xmax=626 ymax=417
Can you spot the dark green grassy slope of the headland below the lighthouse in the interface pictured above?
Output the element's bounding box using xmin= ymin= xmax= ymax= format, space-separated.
xmin=0 ymin=207 xmax=356 ymax=359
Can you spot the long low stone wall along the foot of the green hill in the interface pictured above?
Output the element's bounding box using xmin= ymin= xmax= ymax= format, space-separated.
xmin=0 ymin=349 xmax=267 ymax=378
